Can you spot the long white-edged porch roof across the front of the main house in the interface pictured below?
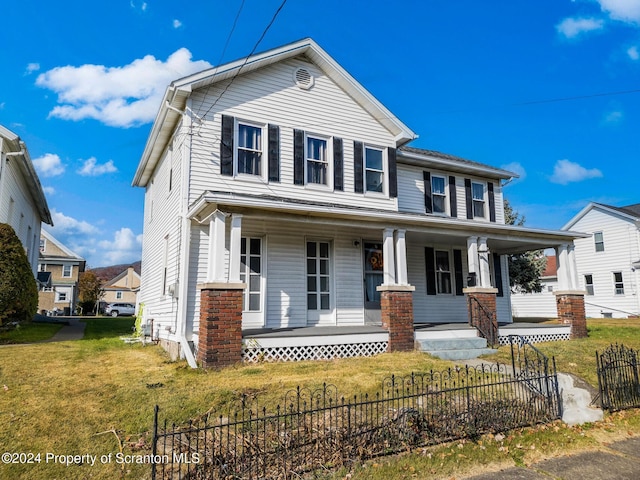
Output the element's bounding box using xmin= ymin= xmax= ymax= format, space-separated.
xmin=188 ymin=191 xmax=588 ymax=254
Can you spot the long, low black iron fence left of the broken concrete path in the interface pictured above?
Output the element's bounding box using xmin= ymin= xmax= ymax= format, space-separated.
xmin=152 ymin=339 xmax=561 ymax=479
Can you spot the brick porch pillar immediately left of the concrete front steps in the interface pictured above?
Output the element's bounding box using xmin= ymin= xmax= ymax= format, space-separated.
xmin=378 ymin=285 xmax=415 ymax=352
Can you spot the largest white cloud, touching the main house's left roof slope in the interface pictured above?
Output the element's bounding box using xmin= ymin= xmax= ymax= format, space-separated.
xmin=36 ymin=48 xmax=211 ymax=128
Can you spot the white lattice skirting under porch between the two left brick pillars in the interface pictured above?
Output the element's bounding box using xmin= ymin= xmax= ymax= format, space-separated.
xmin=242 ymin=342 xmax=387 ymax=363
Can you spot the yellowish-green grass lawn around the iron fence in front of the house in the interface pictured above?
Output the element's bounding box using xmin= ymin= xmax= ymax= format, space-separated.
xmin=0 ymin=318 xmax=640 ymax=480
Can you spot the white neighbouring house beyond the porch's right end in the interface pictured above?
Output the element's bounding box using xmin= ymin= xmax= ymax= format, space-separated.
xmin=512 ymin=202 xmax=640 ymax=318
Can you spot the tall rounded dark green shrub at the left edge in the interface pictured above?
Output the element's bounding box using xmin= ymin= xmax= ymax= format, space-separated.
xmin=0 ymin=223 xmax=38 ymax=325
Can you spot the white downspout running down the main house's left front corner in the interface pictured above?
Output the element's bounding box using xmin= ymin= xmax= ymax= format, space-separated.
xmin=176 ymin=99 xmax=198 ymax=368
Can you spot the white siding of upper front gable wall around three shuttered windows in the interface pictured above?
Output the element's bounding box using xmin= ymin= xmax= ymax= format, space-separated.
xmin=189 ymin=59 xmax=397 ymax=211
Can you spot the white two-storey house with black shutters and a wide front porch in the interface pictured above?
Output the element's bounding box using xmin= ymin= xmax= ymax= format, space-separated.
xmin=133 ymin=39 xmax=575 ymax=368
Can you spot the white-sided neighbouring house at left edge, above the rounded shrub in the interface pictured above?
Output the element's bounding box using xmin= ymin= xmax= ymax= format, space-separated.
xmin=0 ymin=125 xmax=53 ymax=276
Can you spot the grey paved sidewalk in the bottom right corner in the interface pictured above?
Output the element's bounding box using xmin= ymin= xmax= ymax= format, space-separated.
xmin=459 ymin=437 xmax=640 ymax=480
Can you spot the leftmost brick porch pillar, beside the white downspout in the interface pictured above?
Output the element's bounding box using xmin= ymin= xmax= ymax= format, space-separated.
xmin=197 ymin=283 xmax=246 ymax=368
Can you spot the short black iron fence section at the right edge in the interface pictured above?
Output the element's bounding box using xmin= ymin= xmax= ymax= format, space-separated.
xmin=596 ymin=344 xmax=640 ymax=411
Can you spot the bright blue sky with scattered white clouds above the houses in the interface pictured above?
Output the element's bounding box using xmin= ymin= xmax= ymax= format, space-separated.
xmin=0 ymin=0 xmax=640 ymax=267
